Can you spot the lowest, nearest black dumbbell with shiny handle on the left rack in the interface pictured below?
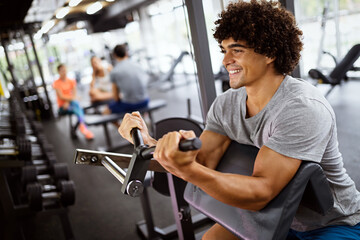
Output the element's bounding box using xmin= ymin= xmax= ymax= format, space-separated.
xmin=26 ymin=180 xmax=75 ymax=211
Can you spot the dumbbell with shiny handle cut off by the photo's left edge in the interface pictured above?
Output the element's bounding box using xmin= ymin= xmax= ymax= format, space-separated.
xmin=0 ymin=137 xmax=32 ymax=161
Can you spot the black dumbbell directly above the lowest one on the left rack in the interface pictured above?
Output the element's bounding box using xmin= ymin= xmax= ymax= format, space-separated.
xmin=21 ymin=163 xmax=69 ymax=186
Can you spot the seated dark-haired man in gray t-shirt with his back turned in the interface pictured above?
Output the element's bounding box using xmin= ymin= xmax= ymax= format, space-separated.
xmin=105 ymin=44 xmax=149 ymax=114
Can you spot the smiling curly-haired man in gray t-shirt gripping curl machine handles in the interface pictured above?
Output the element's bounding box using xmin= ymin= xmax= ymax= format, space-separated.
xmin=119 ymin=0 xmax=360 ymax=239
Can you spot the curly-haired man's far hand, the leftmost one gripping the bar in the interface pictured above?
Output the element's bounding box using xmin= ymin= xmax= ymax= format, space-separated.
xmin=118 ymin=112 xmax=156 ymax=146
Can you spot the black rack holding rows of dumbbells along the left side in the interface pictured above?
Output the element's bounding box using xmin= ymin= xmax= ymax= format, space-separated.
xmin=0 ymin=94 xmax=75 ymax=239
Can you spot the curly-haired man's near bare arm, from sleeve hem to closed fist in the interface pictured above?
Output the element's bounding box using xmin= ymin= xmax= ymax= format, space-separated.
xmin=154 ymin=132 xmax=301 ymax=211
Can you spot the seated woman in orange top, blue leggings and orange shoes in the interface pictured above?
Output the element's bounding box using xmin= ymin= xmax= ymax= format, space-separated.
xmin=53 ymin=64 xmax=94 ymax=140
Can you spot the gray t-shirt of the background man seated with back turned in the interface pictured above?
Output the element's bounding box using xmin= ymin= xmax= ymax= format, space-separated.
xmin=110 ymin=59 xmax=148 ymax=103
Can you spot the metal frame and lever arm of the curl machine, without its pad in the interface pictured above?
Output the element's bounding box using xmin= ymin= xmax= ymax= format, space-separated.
xmin=75 ymin=125 xmax=205 ymax=239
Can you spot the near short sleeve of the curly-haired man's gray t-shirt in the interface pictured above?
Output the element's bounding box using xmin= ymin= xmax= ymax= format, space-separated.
xmin=265 ymin=98 xmax=335 ymax=162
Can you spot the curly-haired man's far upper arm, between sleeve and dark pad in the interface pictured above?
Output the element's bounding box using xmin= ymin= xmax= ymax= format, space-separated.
xmin=197 ymin=130 xmax=231 ymax=169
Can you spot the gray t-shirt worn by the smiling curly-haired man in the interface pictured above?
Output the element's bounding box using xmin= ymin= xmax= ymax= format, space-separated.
xmin=206 ymin=76 xmax=360 ymax=231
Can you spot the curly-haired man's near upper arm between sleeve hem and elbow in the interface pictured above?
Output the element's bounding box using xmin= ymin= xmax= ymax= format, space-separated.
xmin=252 ymin=146 xmax=301 ymax=201
